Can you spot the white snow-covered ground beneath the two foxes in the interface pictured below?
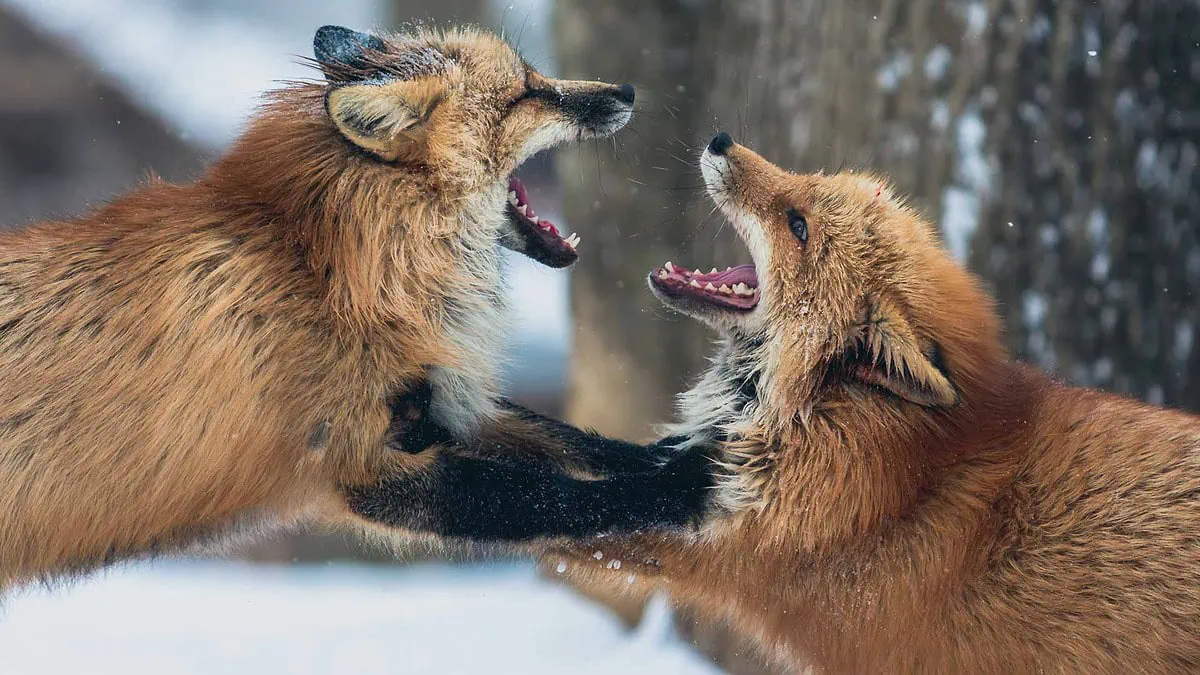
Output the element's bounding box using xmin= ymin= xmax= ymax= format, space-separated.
xmin=0 ymin=562 xmax=718 ymax=675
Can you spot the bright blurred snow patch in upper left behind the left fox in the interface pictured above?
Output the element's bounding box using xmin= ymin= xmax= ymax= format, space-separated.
xmin=5 ymin=0 xmax=377 ymax=147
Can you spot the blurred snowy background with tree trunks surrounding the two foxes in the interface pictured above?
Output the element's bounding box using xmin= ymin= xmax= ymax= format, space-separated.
xmin=0 ymin=0 xmax=1200 ymax=675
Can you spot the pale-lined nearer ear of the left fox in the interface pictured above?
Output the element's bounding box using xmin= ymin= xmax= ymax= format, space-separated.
xmin=325 ymin=78 xmax=445 ymax=162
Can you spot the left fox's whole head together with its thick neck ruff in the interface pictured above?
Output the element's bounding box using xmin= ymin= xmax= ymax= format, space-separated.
xmin=210 ymin=26 xmax=634 ymax=322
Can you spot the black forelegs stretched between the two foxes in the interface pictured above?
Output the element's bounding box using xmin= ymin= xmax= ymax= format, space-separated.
xmin=342 ymin=384 xmax=715 ymax=542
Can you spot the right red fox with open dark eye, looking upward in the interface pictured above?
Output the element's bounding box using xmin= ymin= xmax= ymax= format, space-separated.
xmin=386 ymin=133 xmax=1200 ymax=673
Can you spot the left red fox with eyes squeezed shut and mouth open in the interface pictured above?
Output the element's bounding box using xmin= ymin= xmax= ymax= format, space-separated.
xmin=0 ymin=26 xmax=635 ymax=590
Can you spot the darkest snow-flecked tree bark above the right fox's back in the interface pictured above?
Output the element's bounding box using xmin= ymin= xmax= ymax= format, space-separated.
xmin=971 ymin=0 xmax=1200 ymax=411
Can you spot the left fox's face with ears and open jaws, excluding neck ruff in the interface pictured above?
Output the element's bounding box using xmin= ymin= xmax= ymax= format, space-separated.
xmin=313 ymin=26 xmax=634 ymax=268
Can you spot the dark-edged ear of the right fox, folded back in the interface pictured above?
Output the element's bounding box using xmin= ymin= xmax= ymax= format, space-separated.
xmin=844 ymin=297 xmax=959 ymax=407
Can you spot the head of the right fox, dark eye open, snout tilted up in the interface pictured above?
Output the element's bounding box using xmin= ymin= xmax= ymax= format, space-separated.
xmin=649 ymin=133 xmax=998 ymax=426
